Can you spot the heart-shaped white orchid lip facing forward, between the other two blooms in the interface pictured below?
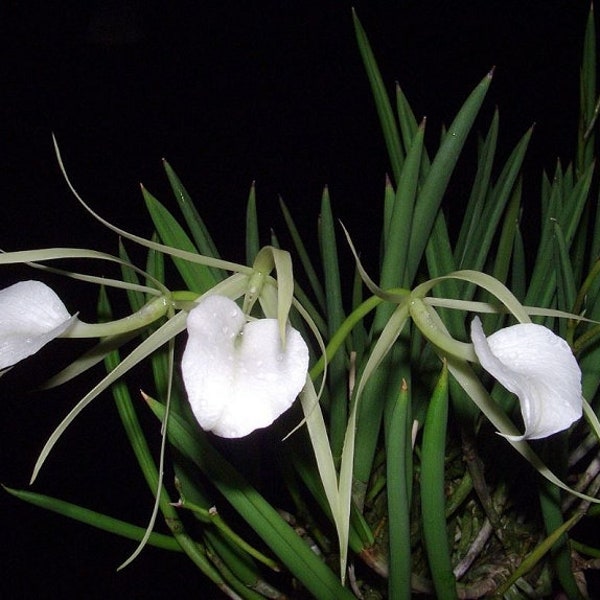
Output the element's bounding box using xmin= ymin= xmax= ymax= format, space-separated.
xmin=181 ymin=295 xmax=308 ymax=438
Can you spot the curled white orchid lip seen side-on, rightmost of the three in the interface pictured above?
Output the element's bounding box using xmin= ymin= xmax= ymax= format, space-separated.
xmin=471 ymin=317 xmax=583 ymax=441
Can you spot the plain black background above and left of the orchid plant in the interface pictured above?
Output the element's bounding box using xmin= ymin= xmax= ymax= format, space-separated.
xmin=0 ymin=0 xmax=589 ymax=598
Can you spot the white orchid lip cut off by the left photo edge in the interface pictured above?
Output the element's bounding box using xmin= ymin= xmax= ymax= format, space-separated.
xmin=0 ymin=280 xmax=76 ymax=369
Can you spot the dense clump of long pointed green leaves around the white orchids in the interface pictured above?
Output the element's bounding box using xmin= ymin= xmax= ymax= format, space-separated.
xmin=3 ymin=4 xmax=600 ymax=600
